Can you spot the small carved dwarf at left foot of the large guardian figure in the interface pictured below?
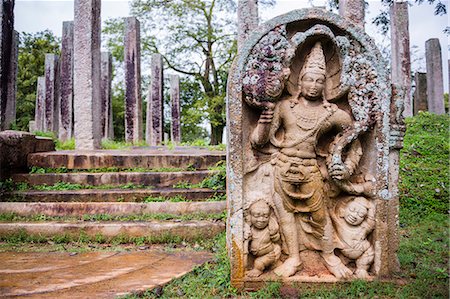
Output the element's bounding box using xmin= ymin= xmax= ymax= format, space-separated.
xmin=246 ymin=199 xmax=281 ymax=277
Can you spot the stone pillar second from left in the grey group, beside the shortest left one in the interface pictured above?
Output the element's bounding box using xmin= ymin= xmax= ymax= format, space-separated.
xmin=44 ymin=54 xmax=59 ymax=134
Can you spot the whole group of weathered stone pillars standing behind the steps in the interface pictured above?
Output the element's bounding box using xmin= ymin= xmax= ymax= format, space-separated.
xmin=34 ymin=0 xmax=181 ymax=149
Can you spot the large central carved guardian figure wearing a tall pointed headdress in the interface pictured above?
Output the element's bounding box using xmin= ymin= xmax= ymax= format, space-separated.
xmin=251 ymin=42 xmax=361 ymax=278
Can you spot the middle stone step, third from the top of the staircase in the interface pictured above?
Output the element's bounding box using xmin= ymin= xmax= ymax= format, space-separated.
xmin=2 ymin=188 xmax=225 ymax=202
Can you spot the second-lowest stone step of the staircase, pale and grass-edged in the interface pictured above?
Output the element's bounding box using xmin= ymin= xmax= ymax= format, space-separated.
xmin=0 ymin=201 xmax=226 ymax=216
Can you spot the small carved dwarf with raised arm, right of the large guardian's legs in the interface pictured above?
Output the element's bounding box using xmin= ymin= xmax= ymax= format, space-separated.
xmin=331 ymin=197 xmax=375 ymax=279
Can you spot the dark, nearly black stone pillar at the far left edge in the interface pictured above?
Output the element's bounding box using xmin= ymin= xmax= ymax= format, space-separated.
xmin=0 ymin=0 xmax=19 ymax=131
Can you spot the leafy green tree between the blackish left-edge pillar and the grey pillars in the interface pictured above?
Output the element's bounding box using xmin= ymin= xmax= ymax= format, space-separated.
xmin=15 ymin=30 xmax=60 ymax=131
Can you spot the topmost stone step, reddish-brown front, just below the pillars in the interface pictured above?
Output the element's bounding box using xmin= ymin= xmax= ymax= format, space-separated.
xmin=28 ymin=148 xmax=226 ymax=170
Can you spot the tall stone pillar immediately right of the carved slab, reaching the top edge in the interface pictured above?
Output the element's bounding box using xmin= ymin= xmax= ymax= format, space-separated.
xmin=390 ymin=1 xmax=412 ymax=117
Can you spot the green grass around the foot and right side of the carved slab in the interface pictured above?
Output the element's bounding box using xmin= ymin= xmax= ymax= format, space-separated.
xmin=121 ymin=113 xmax=450 ymax=298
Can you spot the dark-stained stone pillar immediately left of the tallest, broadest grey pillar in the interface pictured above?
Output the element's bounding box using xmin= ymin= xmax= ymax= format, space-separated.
xmin=58 ymin=21 xmax=73 ymax=141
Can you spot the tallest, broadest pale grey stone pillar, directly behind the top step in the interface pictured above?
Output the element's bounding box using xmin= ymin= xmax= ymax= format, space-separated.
xmin=73 ymin=0 xmax=101 ymax=149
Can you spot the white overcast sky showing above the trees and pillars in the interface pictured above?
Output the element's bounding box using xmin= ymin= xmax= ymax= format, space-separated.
xmin=15 ymin=0 xmax=450 ymax=92
